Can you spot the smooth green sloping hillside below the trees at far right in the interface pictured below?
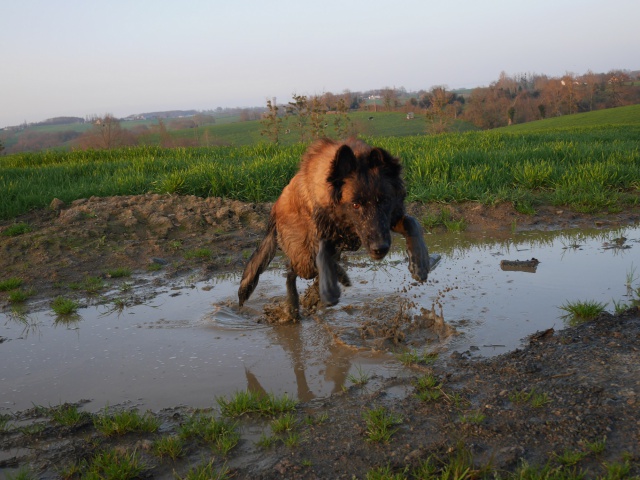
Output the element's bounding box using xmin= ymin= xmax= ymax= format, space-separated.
xmin=496 ymin=105 xmax=640 ymax=133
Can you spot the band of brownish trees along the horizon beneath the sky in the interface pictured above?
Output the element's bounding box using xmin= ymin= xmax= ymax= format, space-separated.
xmin=0 ymin=70 xmax=640 ymax=153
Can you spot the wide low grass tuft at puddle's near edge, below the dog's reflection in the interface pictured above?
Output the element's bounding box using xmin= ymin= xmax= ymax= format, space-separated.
xmin=216 ymin=390 xmax=298 ymax=417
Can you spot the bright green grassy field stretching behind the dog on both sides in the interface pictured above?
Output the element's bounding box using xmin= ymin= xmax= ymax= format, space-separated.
xmin=0 ymin=107 xmax=640 ymax=220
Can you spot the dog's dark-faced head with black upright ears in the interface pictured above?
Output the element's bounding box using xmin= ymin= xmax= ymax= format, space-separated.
xmin=327 ymin=142 xmax=405 ymax=260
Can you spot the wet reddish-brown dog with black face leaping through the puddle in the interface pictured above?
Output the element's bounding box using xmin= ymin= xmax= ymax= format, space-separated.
xmin=238 ymin=139 xmax=429 ymax=320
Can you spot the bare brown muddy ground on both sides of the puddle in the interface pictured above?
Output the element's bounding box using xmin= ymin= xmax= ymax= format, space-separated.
xmin=0 ymin=195 xmax=640 ymax=478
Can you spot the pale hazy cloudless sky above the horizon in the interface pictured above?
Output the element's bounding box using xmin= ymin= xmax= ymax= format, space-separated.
xmin=0 ymin=0 xmax=640 ymax=128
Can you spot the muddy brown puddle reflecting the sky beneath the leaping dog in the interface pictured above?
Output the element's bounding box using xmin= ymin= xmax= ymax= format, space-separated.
xmin=0 ymin=227 xmax=640 ymax=411
